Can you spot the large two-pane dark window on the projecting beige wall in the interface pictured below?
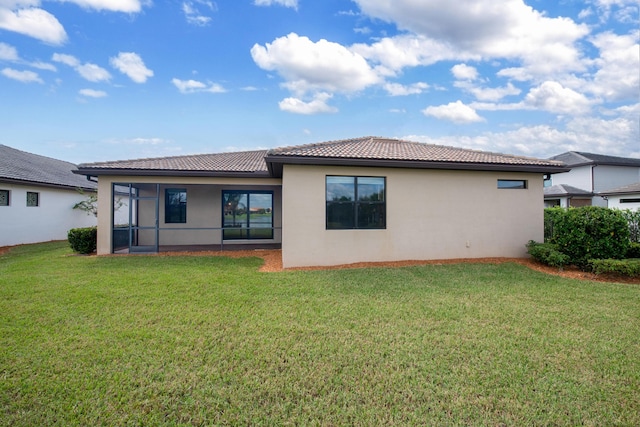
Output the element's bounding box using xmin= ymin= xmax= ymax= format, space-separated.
xmin=326 ymin=176 xmax=386 ymax=230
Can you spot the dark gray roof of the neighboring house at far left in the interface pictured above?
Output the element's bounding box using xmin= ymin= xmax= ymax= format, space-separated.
xmin=0 ymin=144 xmax=97 ymax=190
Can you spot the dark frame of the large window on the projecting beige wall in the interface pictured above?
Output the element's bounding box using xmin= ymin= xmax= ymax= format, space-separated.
xmin=325 ymin=175 xmax=387 ymax=230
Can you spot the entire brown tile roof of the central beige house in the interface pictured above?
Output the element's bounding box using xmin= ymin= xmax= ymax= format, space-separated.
xmin=79 ymin=136 xmax=568 ymax=176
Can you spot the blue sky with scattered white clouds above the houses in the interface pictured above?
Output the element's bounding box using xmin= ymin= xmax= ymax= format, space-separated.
xmin=0 ymin=0 xmax=640 ymax=163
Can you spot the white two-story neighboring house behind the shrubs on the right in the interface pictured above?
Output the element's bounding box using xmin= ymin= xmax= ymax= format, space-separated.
xmin=544 ymin=151 xmax=640 ymax=207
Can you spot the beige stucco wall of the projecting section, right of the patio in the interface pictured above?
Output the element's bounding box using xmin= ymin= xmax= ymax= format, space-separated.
xmin=282 ymin=165 xmax=543 ymax=268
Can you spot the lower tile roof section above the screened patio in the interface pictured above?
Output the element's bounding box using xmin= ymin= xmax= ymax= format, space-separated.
xmin=78 ymin=150 xmax=267 ymax=174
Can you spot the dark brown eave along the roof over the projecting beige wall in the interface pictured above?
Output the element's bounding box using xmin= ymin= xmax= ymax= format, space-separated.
xmin=265 ymin=155 xmax=570 ymax=177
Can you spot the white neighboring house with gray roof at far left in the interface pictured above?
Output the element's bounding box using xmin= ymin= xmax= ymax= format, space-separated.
xmin=0 ymin=145 xmax=97 ymax=246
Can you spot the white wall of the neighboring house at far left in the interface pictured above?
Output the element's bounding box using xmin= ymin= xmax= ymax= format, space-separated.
xmin=0 ymin=183 xmax=96 ymax=246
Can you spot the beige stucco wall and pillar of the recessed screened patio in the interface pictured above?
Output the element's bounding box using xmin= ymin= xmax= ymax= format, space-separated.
xmin=98 ymin=176 xmax=282 ymax=254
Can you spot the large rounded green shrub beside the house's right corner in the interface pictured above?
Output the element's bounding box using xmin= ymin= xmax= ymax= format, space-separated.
xmin=553 ymin=206 xmax=629 ymax=270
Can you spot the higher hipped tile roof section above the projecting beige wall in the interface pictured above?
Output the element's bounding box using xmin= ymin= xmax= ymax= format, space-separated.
xmin=267 ymin=136 xmax=564 ymax=169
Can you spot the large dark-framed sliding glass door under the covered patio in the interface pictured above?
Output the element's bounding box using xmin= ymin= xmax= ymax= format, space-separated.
xmin=222 ymin=190 xmax=273 ymax=240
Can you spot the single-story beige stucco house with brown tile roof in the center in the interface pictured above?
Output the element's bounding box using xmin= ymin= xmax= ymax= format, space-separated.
xmin=75 ymin=137 xmax=568 ymax=268
